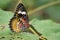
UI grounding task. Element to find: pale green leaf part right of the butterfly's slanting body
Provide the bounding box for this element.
[30,19,60,40]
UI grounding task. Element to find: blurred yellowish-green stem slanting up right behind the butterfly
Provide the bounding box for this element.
[28,1,60,15]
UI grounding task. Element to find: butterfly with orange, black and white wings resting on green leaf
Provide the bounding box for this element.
[9,3,47,40]
